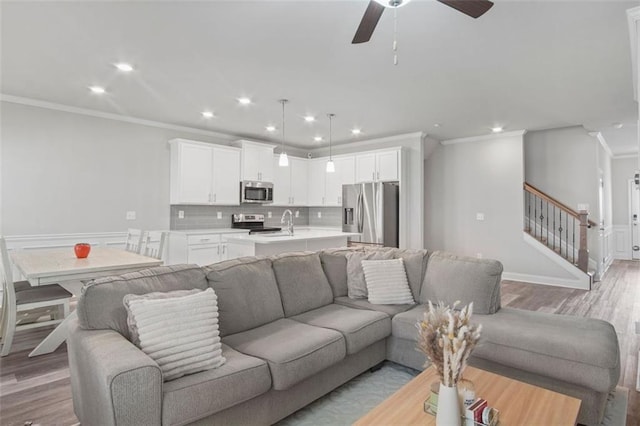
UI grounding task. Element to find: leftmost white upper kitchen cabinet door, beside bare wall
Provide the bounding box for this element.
[171,142,213,204]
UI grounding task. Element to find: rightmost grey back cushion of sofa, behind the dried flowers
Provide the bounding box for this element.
[420,251,502,314]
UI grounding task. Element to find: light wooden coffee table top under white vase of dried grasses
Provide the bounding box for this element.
[355,367,581,426]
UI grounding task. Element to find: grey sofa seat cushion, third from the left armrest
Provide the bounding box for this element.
[291,304,391,355]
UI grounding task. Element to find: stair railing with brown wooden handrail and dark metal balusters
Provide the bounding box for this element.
[523,182,596,288]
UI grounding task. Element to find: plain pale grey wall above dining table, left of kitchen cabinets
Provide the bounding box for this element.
[0,102,232,235]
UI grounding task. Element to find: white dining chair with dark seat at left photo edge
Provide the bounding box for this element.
[0,237,72,356]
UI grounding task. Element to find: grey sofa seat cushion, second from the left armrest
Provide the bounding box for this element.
[222,318,346,390]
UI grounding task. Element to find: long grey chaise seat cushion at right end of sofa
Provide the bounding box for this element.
[471,308,620,392]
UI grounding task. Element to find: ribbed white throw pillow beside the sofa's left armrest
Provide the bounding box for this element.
[123,288,226,381]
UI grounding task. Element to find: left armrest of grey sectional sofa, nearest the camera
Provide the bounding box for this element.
[67,319,162,425]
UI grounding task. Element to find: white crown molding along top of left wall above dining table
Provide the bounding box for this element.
[0,93,241,141]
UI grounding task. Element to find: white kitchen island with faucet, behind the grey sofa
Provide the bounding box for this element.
[227,229,360,257]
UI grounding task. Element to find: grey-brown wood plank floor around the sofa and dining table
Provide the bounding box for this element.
[0,261,640,426]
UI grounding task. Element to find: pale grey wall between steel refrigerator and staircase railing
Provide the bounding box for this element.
[424,132,572,282]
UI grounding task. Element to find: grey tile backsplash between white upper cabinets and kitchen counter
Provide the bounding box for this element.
[170,204,341,231]
